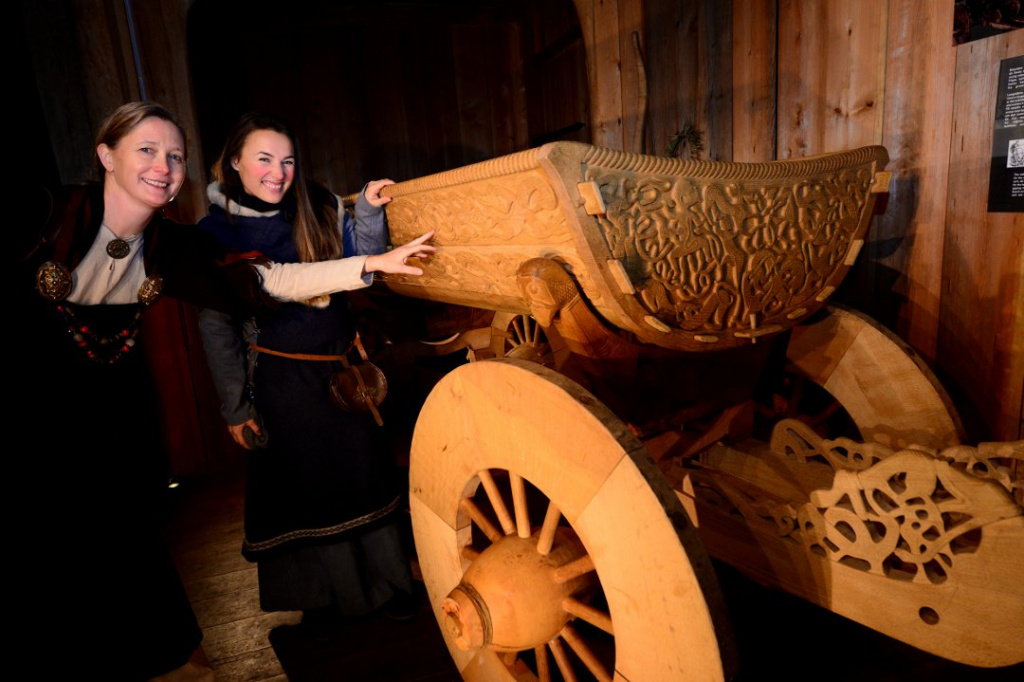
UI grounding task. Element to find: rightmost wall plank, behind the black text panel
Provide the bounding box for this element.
[937,30,1024,440]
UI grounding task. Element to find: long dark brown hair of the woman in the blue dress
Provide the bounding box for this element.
[211,112,342,262]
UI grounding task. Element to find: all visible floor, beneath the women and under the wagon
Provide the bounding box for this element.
[167,458,1024,682]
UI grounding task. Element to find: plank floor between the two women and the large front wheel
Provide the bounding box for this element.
[166,458,461,682]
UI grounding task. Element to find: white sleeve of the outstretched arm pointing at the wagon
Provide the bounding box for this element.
[253,256,374,301]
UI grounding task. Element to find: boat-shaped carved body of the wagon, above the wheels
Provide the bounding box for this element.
[383,142,888,350]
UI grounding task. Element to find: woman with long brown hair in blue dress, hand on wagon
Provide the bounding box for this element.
[200,113,430,636]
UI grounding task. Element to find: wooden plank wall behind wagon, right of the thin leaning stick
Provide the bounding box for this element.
[644,0,1024,440]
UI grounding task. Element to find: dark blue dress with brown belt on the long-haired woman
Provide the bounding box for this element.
[199,185,413,615]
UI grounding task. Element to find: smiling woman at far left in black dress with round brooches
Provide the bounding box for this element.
[14,102,218,682]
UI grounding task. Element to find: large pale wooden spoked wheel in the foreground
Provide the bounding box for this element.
[410,358,733,682]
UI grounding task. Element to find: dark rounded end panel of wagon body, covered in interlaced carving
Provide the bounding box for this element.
[587,166,873,333]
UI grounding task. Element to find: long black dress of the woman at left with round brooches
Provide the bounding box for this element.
[16,187,243,682]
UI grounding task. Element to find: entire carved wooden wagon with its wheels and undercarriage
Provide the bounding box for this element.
[350,142,1024,682]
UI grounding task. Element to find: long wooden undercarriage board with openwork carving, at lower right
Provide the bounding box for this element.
[679,420,1024,667]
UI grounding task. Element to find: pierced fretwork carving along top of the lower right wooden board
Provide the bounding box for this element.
[701,420,1024,584]
